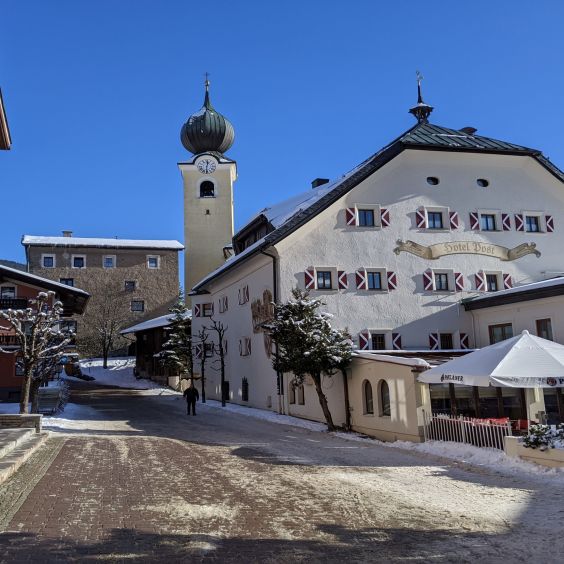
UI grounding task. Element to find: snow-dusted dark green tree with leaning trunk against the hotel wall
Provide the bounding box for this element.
[264,288,353,431]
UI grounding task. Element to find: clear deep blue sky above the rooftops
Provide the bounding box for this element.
[0,0,564,276]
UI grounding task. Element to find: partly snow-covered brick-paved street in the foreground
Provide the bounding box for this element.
[0,387,564,563]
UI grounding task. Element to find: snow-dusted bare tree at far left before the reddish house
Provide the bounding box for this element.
[0,292,70,413]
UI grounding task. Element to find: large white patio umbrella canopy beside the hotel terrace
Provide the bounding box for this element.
[417,331,564,388]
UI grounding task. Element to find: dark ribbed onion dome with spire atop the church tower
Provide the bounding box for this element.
[180,78,235,155]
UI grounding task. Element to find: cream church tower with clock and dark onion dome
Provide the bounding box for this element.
[178,78,237,299]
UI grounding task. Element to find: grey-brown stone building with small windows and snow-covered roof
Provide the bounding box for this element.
[22,231,183,352]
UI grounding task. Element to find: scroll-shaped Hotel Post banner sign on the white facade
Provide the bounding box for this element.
[394,239,541,261]
